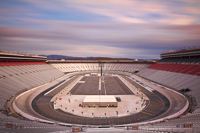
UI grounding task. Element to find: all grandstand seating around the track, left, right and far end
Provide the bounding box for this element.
[0,62,200,132]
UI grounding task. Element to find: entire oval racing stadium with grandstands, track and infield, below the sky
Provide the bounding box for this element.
[0,49,200,133]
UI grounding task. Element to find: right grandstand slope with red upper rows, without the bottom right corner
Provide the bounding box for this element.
[138,63,200,106]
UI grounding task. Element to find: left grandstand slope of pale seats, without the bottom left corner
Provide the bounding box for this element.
[0,63,63,109]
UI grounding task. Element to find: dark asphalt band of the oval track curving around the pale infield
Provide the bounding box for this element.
[32,74,170,125]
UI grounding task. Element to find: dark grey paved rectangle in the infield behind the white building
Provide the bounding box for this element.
[71,75,133,95]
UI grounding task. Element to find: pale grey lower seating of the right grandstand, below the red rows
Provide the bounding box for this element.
[138,64,200,107]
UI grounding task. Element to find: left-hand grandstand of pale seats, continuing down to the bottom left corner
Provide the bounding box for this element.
[0,62,64,132]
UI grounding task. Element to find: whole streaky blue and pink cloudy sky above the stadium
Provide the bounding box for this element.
[0,0,200,59]
